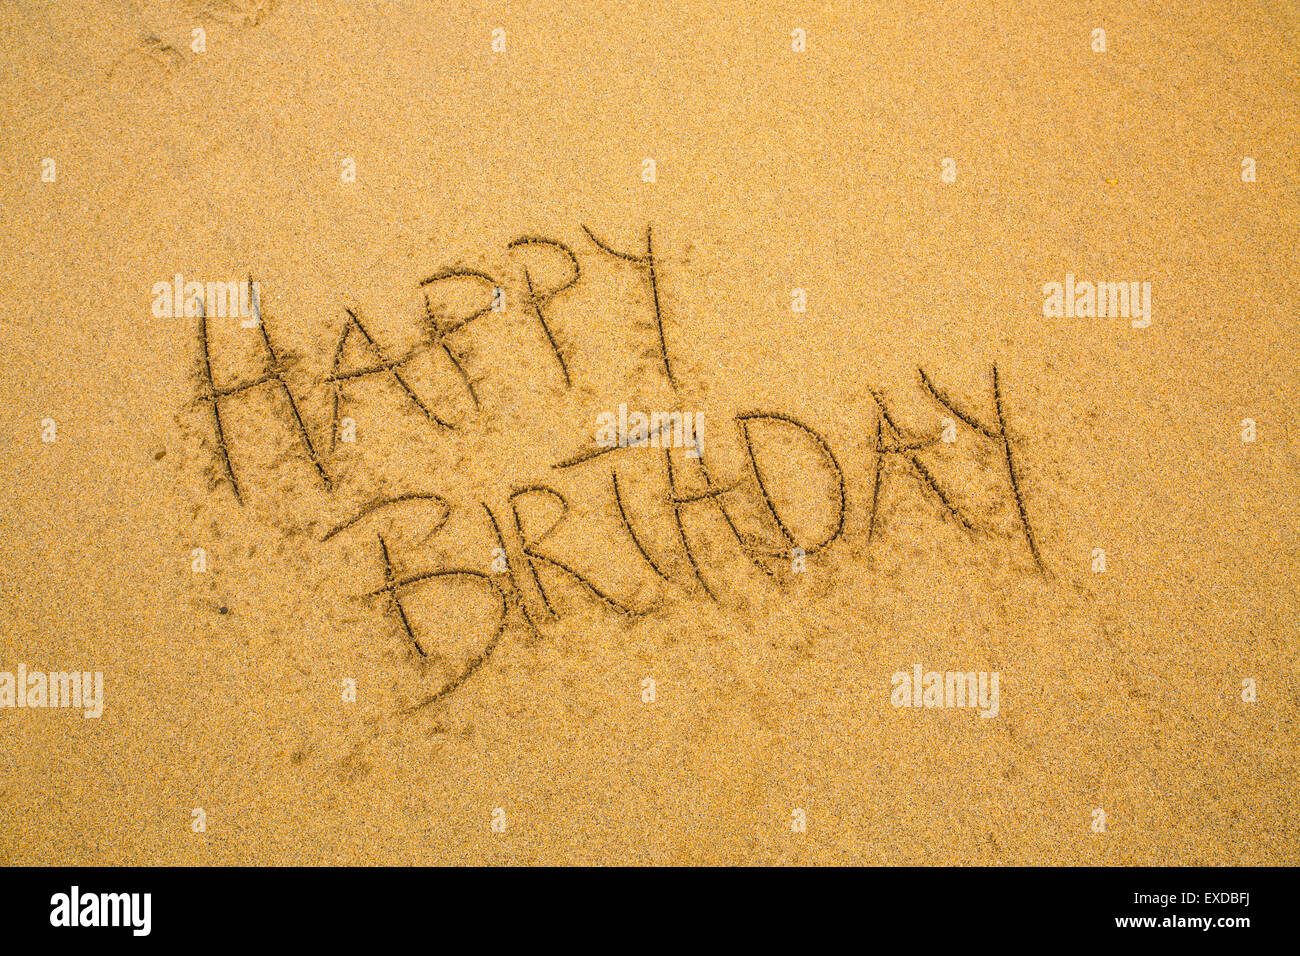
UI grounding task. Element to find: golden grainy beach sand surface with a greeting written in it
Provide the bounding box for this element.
[0,0,1300,865]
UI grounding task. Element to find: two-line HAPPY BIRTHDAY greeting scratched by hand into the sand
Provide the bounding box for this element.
[195,225,1060,717]
